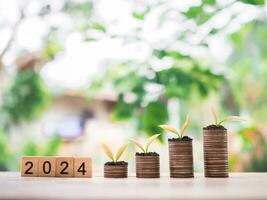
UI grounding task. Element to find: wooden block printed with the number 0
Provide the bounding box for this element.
[38,156,56,177]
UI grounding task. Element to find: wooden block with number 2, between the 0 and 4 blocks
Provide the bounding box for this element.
[56,157,74,177]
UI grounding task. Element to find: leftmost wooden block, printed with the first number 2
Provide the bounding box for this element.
[20,156,39,177]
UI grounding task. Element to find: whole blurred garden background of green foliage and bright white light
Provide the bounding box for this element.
[0,0,267,171]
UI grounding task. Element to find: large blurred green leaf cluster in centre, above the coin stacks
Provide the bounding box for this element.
[91,57,224,139]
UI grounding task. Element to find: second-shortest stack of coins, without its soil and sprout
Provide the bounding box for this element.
[135,155,160,178]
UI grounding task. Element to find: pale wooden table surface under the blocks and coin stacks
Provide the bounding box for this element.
[0,172,267,200]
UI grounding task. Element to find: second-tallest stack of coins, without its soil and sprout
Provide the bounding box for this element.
[169,140,194,178]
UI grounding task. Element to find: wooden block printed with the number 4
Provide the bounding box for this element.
[74,157,92,178]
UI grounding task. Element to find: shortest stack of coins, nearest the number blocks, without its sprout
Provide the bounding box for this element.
[104,163,128,178]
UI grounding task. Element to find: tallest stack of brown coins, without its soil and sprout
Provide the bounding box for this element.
[204,129,229,177]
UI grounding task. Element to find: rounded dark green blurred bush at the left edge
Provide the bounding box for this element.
[2,69,49,122]
